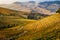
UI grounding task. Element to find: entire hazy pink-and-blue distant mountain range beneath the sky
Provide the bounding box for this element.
[0,1,60,15]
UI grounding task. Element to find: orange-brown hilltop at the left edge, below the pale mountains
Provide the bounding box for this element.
[0,7,24,14]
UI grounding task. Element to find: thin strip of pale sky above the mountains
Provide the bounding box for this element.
[0,0,59,4]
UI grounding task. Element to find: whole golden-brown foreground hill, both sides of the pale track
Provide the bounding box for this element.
[0,13,60,40]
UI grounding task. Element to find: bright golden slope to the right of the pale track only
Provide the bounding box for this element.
[18,14,60,40]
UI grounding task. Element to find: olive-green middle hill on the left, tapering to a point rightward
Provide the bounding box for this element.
[0,16,34,29]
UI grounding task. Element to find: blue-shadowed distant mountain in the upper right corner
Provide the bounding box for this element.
[39,1,60,12]
